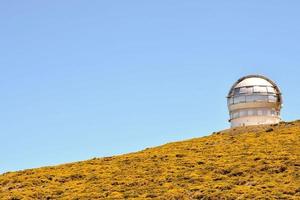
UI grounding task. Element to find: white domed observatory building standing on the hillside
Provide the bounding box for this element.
[227,75,282,127]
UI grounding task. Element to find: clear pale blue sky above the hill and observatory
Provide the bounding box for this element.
[0,0,300,172]
